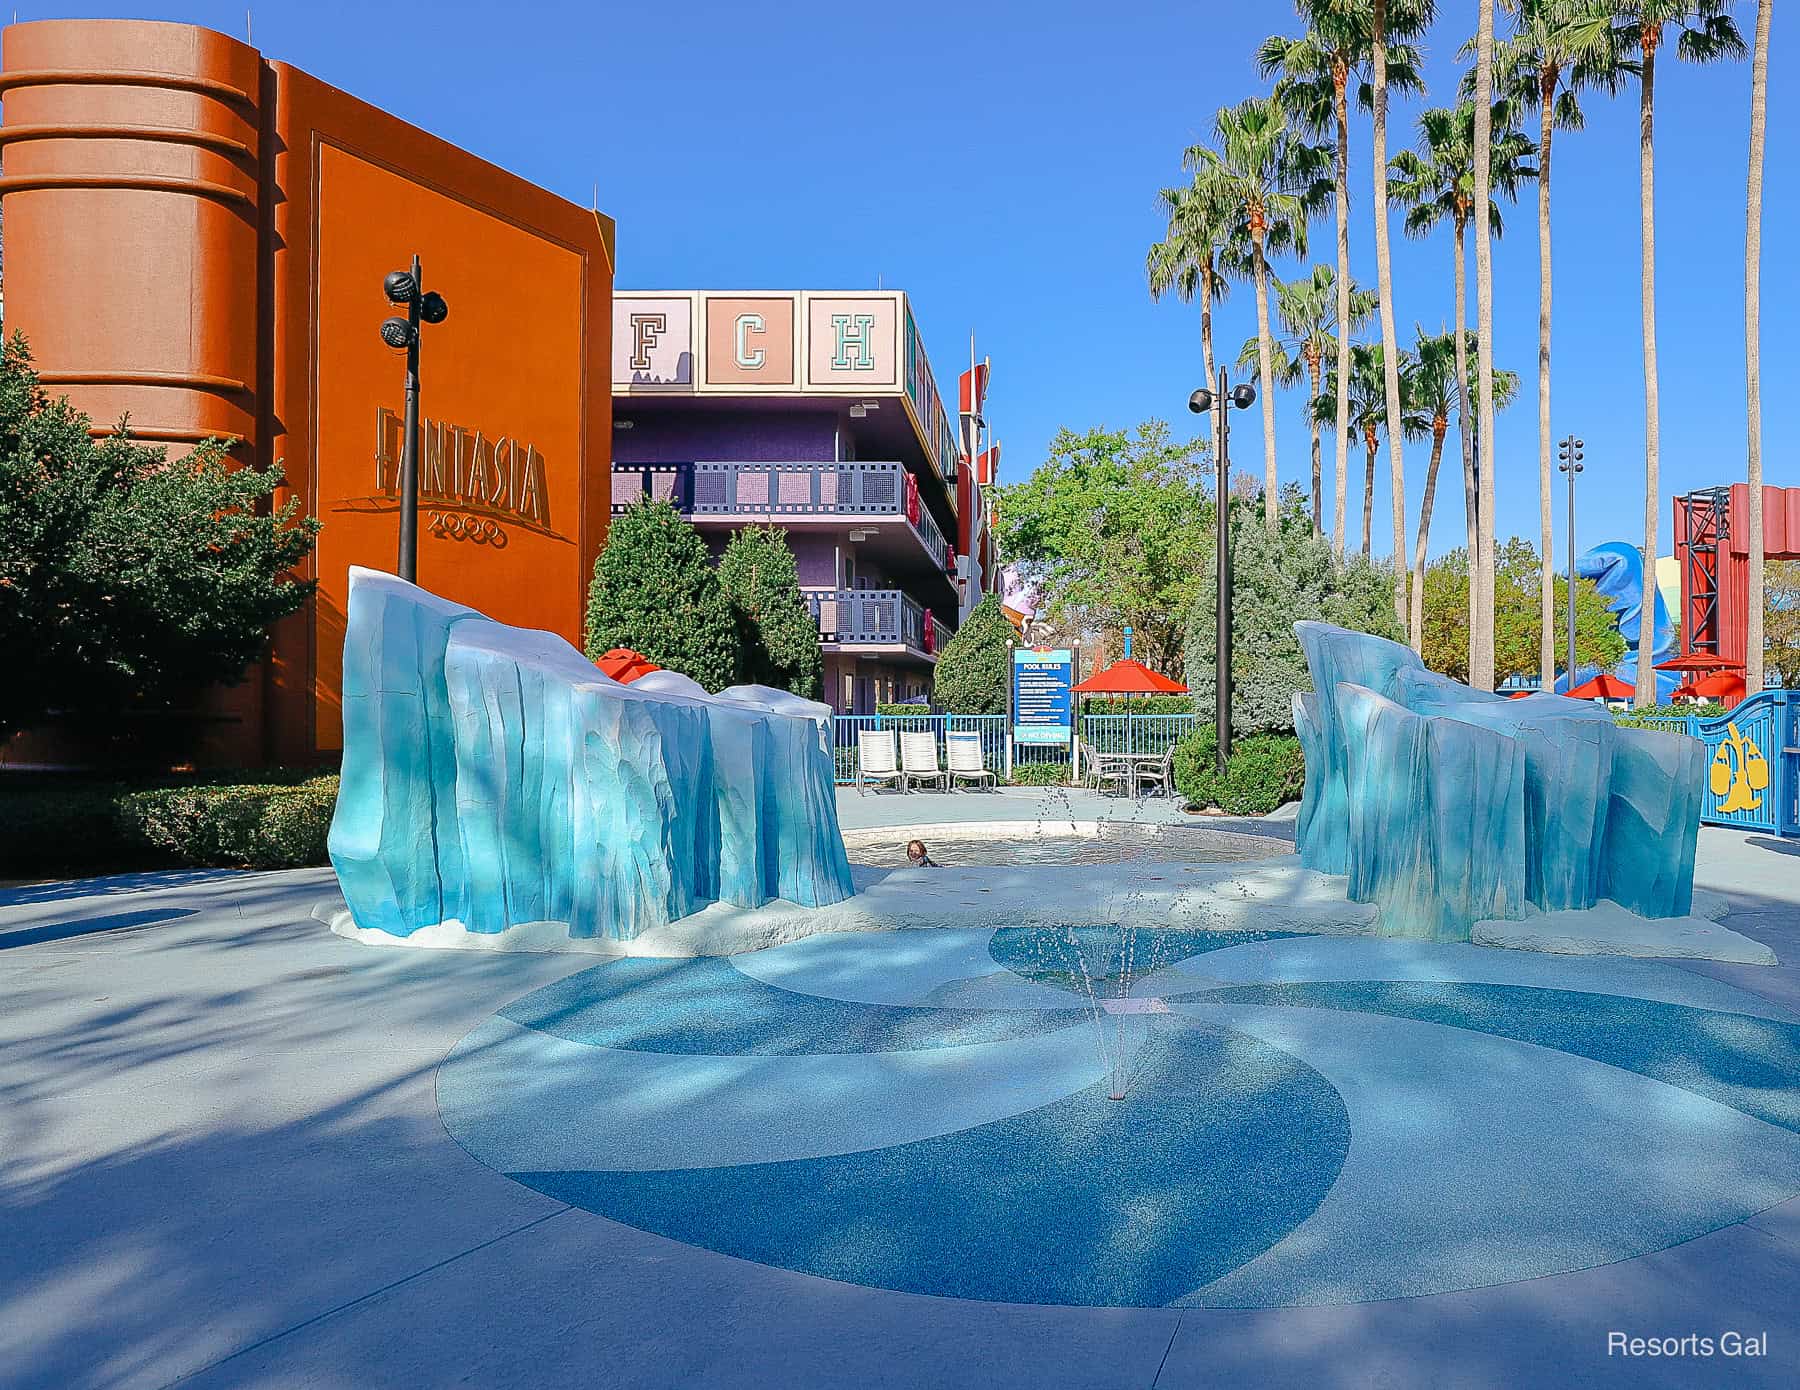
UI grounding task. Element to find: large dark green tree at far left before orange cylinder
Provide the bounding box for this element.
[0,333,319,740]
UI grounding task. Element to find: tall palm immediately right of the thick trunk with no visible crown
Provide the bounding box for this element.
[1490,0,1606,690]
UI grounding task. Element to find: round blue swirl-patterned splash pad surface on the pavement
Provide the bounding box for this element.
[437,927,1800,1307]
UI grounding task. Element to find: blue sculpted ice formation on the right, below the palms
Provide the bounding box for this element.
[1294,623,1705,942]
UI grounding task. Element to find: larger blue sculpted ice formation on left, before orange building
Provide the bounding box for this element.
[329,569,853,949]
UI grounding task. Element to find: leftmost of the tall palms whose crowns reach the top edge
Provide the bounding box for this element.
[1256,0,1422,560]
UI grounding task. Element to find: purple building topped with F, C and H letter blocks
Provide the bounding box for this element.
[612,292,981,713]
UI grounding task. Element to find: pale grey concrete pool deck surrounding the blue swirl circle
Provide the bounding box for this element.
[0,790,1800,1390]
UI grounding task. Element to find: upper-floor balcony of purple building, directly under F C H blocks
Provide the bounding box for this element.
[612,461,956,578]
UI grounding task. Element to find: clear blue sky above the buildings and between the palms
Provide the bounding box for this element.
[18,0,1800,555]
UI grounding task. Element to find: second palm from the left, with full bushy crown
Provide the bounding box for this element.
[1186,97,1330,531]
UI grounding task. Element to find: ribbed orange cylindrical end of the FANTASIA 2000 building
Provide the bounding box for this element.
[0,20,263,452]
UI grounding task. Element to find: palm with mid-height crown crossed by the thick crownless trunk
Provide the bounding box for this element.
[1391,101,1534,655]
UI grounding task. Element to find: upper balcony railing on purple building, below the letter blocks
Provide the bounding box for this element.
[612,461,956,573]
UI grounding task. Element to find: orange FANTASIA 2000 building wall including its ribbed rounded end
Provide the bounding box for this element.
[0,20,612,762]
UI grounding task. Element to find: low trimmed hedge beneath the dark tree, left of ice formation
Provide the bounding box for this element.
[0,772,338,877]
